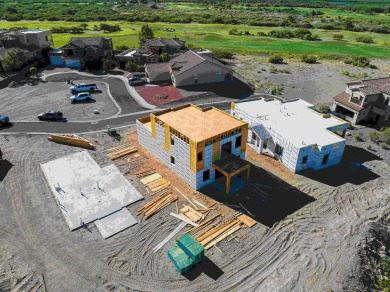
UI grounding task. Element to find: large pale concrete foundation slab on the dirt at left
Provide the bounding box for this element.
[41,151,143,230]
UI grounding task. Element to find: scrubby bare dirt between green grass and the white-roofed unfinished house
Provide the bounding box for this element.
[229,55,390,105]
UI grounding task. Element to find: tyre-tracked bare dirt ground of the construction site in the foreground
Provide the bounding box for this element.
[0,128,390,291]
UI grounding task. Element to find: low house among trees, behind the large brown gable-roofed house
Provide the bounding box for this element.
[115,38,186,67]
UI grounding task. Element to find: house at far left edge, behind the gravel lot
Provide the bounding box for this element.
[0,30,54,71]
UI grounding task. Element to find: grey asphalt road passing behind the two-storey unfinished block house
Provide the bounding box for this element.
[0,102,230,135]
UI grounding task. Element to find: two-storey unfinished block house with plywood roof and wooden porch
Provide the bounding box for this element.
[137,104,249,192]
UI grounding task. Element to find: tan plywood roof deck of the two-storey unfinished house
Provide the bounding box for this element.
[157,106,246,142]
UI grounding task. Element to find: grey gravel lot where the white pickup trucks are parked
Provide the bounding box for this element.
[0,82,119,121]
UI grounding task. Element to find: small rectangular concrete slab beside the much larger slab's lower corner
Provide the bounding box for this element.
[95,208,137,239]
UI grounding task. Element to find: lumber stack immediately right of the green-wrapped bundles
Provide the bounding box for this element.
[195,219,241,250]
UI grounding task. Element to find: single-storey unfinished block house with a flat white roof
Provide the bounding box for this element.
[231,98,348,172]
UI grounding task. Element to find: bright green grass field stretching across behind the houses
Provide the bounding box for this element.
[0,21,390,57]
